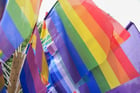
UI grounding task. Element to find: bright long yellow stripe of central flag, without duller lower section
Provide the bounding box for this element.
[59,0,106,64]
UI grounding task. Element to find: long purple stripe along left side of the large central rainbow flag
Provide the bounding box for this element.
[46,18,81,83]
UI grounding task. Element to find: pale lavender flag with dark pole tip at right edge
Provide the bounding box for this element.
[121,23,140,73]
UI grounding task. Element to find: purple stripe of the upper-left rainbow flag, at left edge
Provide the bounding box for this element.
[0,26,15,61]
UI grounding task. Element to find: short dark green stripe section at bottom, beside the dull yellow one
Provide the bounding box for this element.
[91,66,111,93]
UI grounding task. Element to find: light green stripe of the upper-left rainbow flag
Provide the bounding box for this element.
[7,0,32,39]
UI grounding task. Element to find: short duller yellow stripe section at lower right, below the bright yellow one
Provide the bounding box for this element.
[100,60,120,89]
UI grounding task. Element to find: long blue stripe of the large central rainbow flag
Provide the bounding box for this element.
[49,9,88,76]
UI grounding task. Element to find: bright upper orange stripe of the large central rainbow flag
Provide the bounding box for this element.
[73,5,110,54]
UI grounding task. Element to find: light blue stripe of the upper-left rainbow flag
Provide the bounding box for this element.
[1,11,24,49]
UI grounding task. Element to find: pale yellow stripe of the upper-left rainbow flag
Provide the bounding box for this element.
[16,0,37,28]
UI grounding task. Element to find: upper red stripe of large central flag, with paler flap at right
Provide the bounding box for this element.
[82,0,130,41]
